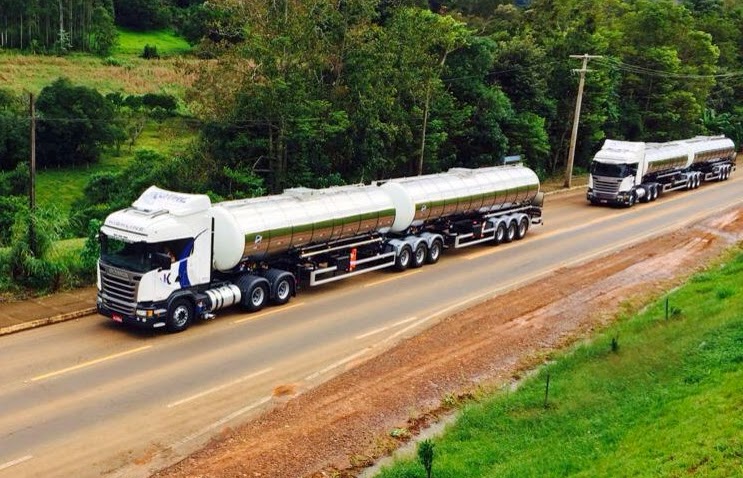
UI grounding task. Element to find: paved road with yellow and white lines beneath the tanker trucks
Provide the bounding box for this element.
[0,172,743,478]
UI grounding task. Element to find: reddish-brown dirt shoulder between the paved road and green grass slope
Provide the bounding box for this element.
[155,208,743,478]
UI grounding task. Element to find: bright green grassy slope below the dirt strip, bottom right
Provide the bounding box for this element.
[379,248,743,478]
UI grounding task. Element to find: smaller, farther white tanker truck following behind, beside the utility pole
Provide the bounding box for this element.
[586,136,735,207]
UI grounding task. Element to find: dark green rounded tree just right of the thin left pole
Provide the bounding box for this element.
[36,78,117,166]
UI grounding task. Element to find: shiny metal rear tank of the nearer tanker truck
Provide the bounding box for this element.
[381,165,539,232]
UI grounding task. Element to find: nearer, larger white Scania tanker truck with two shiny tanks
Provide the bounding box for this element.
[97,165,543,332]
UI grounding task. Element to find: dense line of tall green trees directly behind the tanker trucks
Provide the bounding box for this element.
[182,0,743,195]
